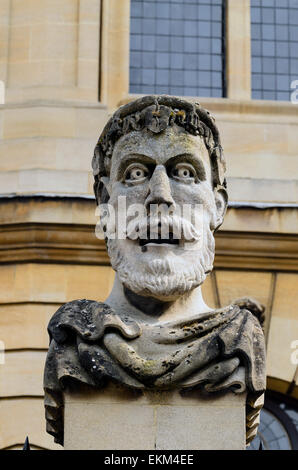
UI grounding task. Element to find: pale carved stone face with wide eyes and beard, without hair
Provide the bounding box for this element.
[102,125,226,300]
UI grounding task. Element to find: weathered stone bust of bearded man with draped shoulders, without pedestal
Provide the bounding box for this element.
[44,95,266,444]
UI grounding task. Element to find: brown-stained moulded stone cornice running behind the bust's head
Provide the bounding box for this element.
[0,222,298,271]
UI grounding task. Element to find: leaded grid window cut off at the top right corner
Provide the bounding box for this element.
[251,0,298,101]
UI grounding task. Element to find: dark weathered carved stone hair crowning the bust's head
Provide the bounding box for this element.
[92,95,226,202]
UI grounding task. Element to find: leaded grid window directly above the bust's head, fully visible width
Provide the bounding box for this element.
[130,0,225,97]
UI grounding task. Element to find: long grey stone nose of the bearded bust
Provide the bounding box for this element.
[145,165,175,210]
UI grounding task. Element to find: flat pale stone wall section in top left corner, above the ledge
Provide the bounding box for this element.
[0,0,101,103]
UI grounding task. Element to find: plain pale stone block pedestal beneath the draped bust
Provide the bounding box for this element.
[64,385,246,450]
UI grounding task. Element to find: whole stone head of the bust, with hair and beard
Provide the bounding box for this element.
[92,95,227,300]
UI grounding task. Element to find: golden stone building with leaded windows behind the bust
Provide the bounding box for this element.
[0,0,298,449]
